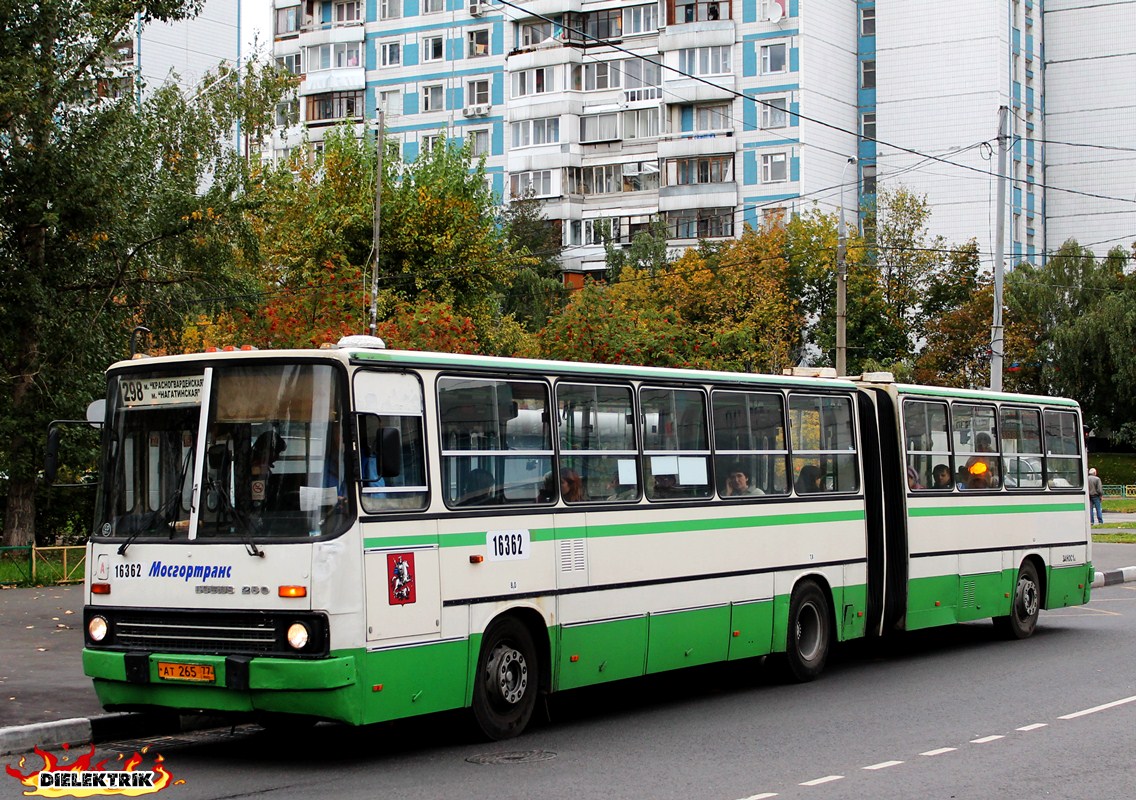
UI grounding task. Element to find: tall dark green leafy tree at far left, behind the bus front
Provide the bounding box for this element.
[0,0,284,544]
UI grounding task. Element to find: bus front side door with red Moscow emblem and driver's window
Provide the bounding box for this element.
[354,370,442,642]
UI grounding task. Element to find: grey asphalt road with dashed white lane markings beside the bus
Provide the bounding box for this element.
[0,563,1136,800]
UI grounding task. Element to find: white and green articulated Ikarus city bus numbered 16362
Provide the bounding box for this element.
[83,338,1092,739]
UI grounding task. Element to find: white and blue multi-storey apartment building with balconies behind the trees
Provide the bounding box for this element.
[274,0,1136,272]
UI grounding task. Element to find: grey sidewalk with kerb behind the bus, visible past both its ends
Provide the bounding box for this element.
[0,543,1136,756]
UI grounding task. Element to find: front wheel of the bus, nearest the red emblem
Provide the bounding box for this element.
[473,617,541,741]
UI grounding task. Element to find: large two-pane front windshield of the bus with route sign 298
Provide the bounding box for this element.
[95,364,353,541]
